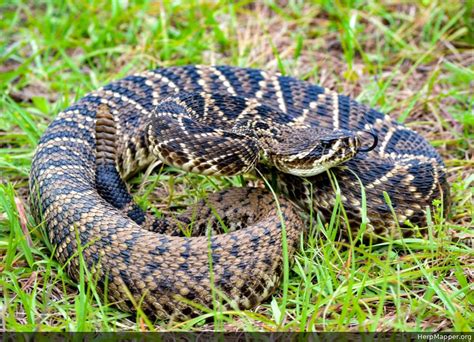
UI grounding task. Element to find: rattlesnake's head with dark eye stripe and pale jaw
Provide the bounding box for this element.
[263,127,368,177]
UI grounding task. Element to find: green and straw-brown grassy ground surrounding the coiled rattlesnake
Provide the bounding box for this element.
[0,0,474,331]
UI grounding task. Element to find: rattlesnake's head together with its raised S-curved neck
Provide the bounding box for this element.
[124,93,360,177]
